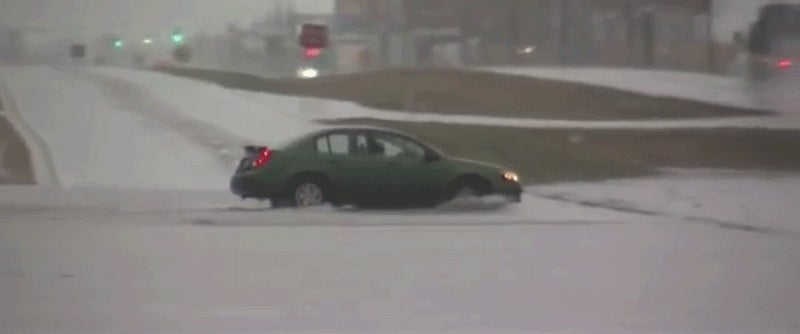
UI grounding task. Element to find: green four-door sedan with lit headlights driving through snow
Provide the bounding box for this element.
[230,127,522,208]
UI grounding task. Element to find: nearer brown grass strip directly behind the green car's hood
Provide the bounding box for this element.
[318,119,800,184]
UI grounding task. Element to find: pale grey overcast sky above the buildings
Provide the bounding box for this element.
[0,0,797,39]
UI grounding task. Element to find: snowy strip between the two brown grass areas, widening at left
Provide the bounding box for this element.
[83,68,800,134]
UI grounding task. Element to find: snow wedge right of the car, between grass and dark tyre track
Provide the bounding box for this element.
[529,170,800,237]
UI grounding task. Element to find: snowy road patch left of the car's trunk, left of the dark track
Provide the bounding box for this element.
[0,67,241,189]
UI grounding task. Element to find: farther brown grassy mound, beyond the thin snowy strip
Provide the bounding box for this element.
[154,67,771,120]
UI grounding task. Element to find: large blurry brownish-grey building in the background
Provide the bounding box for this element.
[334,0,715,70]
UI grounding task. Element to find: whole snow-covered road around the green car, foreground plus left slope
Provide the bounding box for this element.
[0,67,800,334]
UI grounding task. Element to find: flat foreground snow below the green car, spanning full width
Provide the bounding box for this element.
[0,181,800,334]
